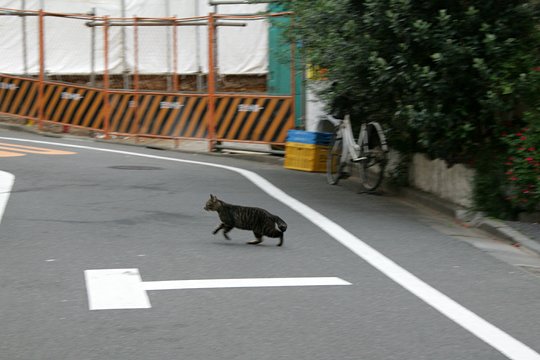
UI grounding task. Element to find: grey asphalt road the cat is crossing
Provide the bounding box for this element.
[0,130,540,360]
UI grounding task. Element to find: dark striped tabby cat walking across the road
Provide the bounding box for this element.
[204,195,287,246]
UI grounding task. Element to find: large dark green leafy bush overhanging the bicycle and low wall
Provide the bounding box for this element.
[280,0,540,217]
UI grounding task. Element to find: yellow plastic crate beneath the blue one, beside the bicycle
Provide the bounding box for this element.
[284,142,328,172]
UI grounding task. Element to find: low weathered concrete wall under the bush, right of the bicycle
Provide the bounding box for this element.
[409,154,474,207]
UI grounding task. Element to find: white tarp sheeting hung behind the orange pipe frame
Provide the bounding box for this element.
[0,0,268,74]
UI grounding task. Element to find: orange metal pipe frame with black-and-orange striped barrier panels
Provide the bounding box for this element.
[0,7,295,151]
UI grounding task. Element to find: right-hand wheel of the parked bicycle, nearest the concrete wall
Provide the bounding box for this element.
[358,124,387,192]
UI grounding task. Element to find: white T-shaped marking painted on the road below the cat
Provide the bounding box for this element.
[84,269,351,310]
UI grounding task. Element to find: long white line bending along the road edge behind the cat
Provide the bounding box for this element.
[4,137,540,360]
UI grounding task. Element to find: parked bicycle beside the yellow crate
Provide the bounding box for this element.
[326,115,388,192]
